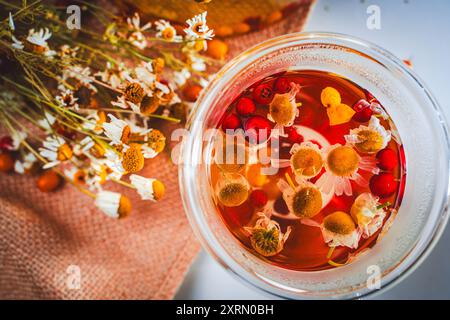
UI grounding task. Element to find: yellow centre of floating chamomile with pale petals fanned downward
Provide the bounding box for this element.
[327,146,359,177]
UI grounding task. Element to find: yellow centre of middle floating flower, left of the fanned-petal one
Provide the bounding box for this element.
[291,148,323,177]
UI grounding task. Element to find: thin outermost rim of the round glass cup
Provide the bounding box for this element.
[179,32,450,299]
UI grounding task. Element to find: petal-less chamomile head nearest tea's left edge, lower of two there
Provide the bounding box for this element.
[216,173,250,207]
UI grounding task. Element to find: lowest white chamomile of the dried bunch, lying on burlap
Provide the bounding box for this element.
[95,191,131,219]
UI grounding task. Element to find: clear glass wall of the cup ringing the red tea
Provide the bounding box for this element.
[179,33,449,299]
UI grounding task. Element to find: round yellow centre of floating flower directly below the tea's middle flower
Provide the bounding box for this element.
[292,187,322,218]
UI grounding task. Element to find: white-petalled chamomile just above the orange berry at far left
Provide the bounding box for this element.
[39,136,73,169]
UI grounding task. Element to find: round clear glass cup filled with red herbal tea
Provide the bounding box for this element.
[179,33,449,299]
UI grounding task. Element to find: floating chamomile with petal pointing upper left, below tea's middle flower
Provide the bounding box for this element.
[277,179,323,218]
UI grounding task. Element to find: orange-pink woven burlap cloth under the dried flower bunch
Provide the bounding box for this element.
[0,0,313,299]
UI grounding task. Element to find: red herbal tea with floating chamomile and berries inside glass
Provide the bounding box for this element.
[210,71,406,271]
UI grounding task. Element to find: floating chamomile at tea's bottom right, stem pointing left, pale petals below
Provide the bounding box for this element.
[301,211,361,249]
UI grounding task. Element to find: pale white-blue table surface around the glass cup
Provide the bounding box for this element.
[175,0,450,299]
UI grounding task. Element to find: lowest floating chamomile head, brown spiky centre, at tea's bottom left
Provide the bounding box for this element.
[245,212,291,257]
